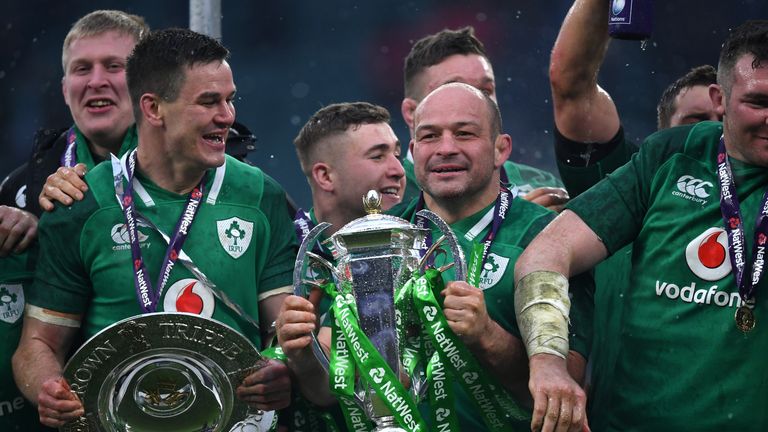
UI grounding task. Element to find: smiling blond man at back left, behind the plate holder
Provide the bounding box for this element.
[0,10,149,221]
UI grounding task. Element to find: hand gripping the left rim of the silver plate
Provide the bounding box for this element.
[37,377,85,427]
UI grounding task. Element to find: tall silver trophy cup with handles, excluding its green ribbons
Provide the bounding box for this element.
[293,191,466,431]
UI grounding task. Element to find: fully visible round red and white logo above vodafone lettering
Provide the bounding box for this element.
[685,228,731,281]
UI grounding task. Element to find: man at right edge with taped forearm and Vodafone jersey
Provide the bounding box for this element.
[515,20,768,431]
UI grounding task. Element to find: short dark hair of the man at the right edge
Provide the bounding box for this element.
[717,20,768,97]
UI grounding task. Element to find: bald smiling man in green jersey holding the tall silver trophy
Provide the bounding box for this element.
[277,83,591,431]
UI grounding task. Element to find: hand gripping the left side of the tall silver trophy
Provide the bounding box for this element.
[275,295,317,366]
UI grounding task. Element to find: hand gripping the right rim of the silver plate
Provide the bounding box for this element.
[236,360,291,411]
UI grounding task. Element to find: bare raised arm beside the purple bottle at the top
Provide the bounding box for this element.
[549,0,620,143]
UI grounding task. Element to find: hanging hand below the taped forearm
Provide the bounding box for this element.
[528,354,589,432]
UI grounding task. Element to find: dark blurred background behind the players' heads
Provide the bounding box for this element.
[0,0,768,208]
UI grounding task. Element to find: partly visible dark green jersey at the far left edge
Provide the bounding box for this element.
[0,246,46,432]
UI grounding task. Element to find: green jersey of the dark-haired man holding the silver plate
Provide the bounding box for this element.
[29,156,296,347]
